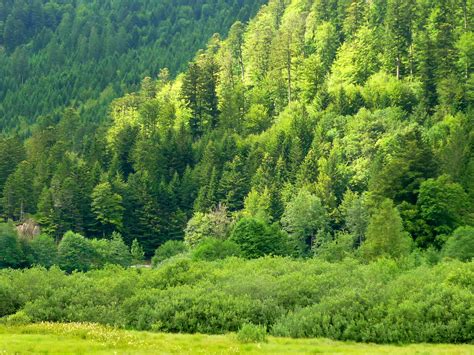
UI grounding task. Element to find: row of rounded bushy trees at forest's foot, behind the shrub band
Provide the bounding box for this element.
[0,220,474,273]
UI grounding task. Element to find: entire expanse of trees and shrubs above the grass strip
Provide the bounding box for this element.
[0,0,474,343]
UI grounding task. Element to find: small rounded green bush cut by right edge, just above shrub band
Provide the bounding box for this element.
[442,226,474,261]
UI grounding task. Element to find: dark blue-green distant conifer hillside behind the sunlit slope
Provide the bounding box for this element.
[0,0,264,135]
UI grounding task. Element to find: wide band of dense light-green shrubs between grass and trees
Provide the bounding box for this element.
[0,257,474,343]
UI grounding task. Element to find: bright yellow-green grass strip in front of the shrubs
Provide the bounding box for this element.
[0,323,474,354]
